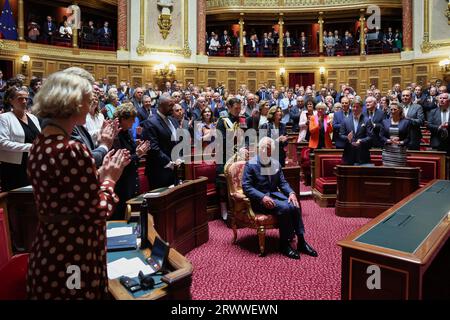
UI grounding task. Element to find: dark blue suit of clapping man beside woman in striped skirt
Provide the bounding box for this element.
[339,114,372,165]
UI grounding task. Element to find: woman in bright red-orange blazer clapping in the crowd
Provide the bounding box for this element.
[309,102,333,149]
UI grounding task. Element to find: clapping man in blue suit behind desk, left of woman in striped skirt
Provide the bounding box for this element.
[339,97,372,165]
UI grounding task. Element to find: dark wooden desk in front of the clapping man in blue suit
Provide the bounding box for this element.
[335,166,420,218]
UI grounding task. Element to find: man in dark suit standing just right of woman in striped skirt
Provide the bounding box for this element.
[402,90,425,150]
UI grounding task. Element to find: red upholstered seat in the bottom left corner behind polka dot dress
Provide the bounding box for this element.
[0,253,28,300]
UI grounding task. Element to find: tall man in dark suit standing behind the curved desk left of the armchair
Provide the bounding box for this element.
[141,93,181,190]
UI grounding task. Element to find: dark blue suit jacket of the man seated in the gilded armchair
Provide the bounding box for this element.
[242,157,294,212]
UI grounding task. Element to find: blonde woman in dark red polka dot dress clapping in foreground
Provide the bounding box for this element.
[27,72,130,299]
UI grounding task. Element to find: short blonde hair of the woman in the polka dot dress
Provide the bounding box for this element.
[33,71,92,118]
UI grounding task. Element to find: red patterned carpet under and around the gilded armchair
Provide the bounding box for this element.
[187,185,369,300]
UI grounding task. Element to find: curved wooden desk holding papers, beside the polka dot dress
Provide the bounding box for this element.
[107,215,193,300]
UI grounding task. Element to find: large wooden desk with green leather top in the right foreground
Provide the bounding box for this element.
[338,180,450,300]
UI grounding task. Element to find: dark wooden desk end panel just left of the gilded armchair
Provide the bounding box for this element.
[127,177,209,254]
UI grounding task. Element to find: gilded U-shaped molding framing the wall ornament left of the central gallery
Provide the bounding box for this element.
[136,0,192,58]
